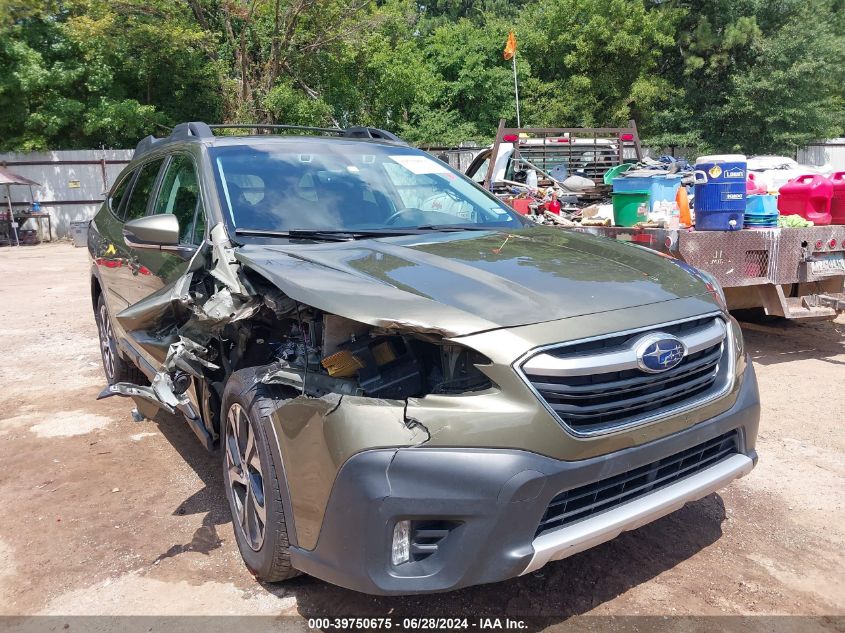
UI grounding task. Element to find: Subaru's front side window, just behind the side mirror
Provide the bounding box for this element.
[153,154,205,244]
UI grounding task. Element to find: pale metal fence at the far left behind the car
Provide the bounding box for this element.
[0,149,135,238]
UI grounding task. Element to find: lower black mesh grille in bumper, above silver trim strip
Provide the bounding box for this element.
[535,431,739,536]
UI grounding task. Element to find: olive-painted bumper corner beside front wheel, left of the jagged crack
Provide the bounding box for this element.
[271,393,428,549]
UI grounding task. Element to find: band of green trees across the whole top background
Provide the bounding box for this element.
[0,0,845,153]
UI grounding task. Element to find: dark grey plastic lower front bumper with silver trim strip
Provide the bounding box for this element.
[291,364,760,594]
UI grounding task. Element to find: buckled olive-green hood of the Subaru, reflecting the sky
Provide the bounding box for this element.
[236,226,715,336]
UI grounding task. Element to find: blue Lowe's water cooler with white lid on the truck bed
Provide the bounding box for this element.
[695,154,748,231]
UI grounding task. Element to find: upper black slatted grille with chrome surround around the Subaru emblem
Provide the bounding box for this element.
[522,317,729,434]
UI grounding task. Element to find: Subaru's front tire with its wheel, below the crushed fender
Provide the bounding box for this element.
[220,369,299,582]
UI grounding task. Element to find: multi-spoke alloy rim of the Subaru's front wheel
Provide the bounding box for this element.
[224,404,267,552]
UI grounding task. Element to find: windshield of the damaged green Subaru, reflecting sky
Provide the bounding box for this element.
[211,139,524,233]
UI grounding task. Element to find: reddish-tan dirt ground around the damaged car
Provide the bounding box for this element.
[0,244,845,622]
